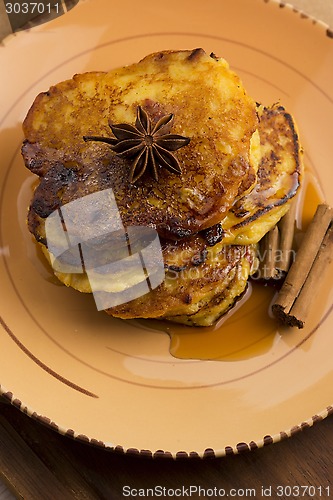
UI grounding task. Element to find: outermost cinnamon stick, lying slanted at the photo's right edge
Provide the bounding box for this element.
[272,204,333,328]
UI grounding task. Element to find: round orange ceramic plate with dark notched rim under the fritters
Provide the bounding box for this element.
[0,0,333,456]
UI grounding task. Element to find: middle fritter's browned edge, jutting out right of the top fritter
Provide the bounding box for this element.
[147,105,302,269]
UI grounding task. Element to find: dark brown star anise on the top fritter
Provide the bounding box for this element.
[83,106,190,183]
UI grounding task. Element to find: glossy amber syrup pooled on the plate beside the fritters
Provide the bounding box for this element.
[164,170,323,361]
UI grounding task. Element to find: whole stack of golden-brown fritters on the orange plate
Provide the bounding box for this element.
[22,49,301,326]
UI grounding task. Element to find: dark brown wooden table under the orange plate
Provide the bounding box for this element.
[0,0,333,500]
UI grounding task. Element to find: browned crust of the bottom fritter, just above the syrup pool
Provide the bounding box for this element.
[106,245,256,326]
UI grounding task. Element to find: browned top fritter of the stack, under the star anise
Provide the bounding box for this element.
[22,50,257,241]
